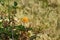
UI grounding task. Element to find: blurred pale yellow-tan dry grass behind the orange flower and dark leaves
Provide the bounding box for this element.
[0,0,60,40]
